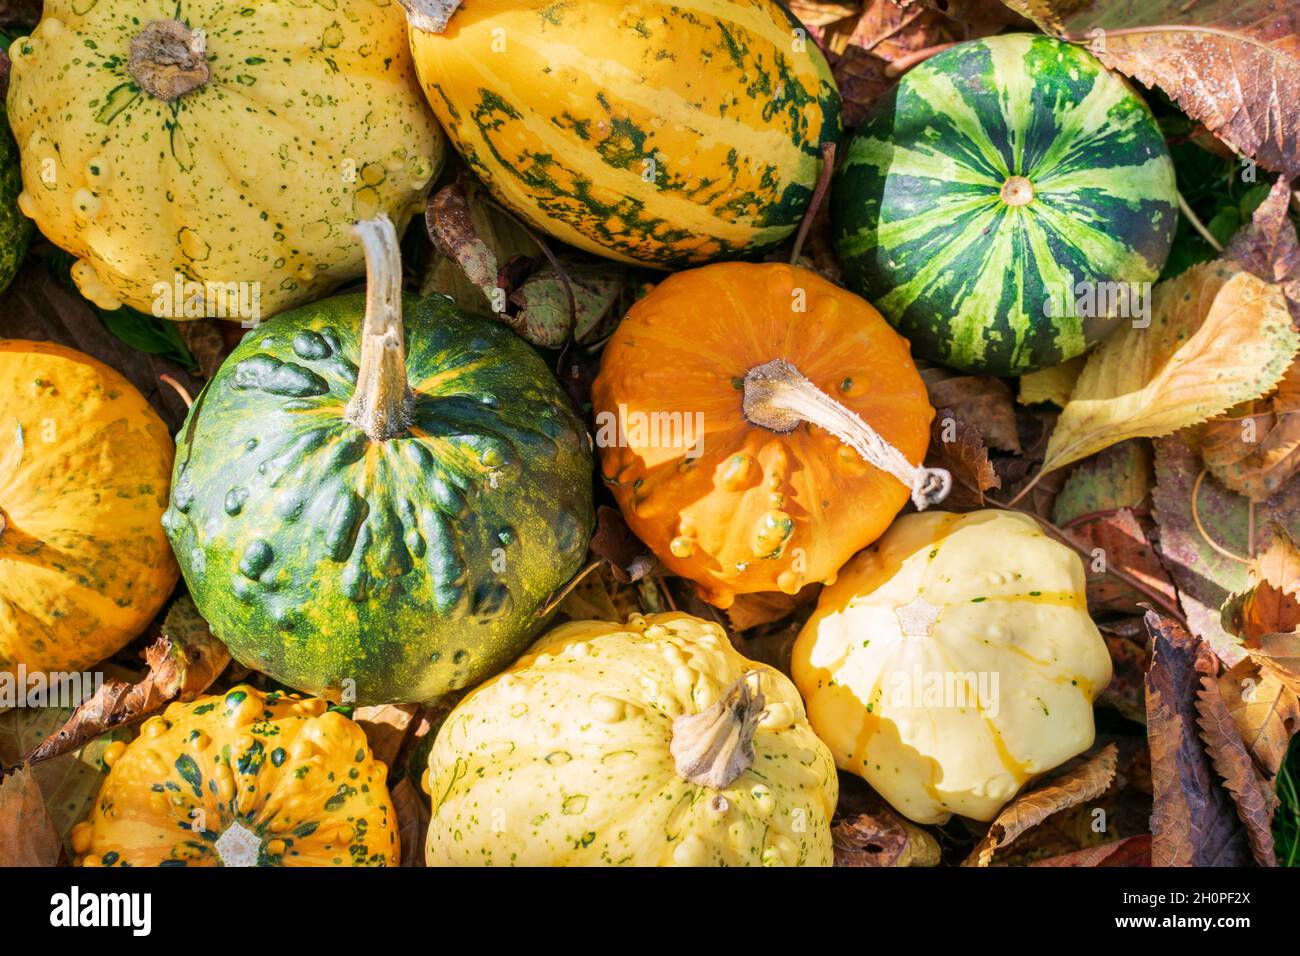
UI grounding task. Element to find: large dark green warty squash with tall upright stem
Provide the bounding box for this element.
[164,219,594,704]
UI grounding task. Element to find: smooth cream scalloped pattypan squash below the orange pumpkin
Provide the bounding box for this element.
[792,511,1110,823]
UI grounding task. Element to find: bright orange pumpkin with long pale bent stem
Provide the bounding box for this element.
[593,263,950,607]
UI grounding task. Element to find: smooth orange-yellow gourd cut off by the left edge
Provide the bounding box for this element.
[0,339,178,674]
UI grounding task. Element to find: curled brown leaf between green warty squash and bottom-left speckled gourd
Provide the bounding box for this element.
[27,596,230,762]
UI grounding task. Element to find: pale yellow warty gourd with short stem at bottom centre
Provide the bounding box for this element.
[425,614,839,866]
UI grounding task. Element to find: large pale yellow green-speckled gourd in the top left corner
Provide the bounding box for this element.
[8,0,446,319]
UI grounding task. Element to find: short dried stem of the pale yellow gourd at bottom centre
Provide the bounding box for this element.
[668,671,767,790]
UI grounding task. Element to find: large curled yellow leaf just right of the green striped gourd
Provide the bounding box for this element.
[1043,260,1300,473]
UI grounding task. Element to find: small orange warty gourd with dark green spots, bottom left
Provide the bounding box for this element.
[72,685,399,866]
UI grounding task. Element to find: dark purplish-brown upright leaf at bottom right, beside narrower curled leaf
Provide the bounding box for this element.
[1145,611,1253,866]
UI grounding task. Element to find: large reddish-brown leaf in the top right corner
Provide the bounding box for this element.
[1005,0,1300,178]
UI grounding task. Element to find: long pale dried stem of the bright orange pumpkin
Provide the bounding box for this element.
[744,359,953,511]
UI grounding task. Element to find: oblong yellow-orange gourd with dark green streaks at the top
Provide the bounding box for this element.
[402,0,840,268]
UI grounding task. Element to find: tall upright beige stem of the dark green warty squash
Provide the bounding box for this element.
[343,215,411,442]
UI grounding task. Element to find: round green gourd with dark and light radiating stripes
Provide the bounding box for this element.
[832,34,1177,375]
